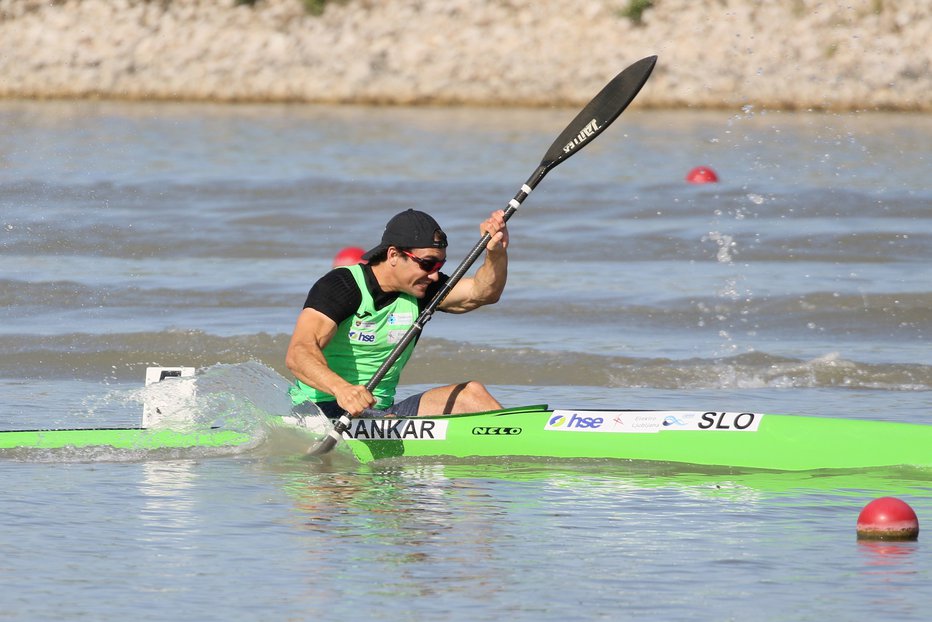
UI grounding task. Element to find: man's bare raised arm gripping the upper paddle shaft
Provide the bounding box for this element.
[440,210,508,313]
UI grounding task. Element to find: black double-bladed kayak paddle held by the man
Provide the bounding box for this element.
[307,56,657,456]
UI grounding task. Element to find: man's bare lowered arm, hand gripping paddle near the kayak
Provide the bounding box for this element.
[285,308,375,417]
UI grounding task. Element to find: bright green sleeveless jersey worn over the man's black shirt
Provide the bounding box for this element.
[289,265,420,409]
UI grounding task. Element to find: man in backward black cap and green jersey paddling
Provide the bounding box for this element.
[285,209,508,417]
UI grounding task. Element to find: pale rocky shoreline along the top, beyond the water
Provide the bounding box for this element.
[0,0,932,111]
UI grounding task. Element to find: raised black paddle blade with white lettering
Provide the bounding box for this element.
[540,56,657,171]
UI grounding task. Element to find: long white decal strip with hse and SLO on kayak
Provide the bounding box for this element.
[544,410,764,434]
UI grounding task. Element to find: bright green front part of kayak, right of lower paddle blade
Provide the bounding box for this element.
[344,406,932,471]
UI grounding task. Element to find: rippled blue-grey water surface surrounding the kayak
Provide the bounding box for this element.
[0,102,932,620]
